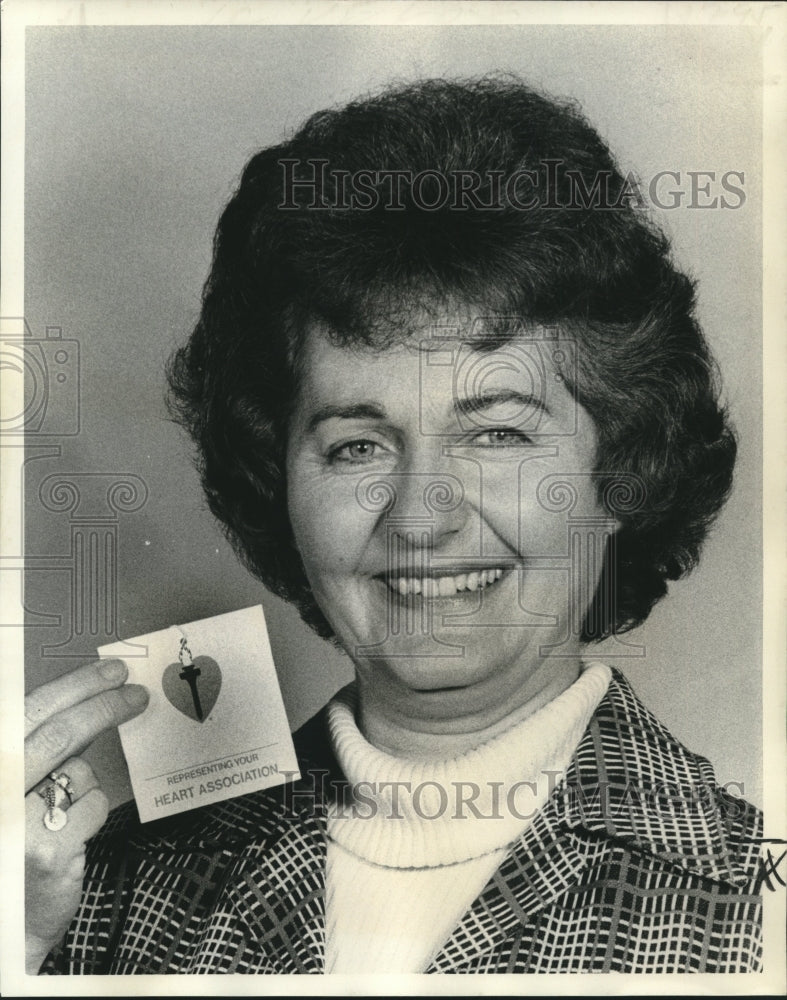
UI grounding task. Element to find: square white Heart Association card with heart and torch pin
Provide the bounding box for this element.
[98,605,300,823]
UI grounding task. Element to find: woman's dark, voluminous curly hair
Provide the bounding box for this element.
[168,76,736,642]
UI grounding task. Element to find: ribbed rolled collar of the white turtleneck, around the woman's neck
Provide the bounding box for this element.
[327,663,611,868]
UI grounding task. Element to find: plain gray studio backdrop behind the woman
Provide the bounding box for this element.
[25,26,762,803]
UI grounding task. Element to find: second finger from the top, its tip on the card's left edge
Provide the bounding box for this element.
[25,684,148,789]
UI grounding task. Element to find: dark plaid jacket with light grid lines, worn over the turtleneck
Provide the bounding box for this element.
[42,672,761,974]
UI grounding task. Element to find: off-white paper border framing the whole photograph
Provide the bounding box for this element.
[0,0,787,996]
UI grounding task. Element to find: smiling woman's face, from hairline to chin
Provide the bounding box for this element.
[287,325,613,727]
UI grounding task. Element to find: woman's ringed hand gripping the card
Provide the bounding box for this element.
[25,660,148,974]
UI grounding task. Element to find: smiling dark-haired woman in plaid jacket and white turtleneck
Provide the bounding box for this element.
[27,79,760,973]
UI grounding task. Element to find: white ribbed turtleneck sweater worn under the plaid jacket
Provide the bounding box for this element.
[325,661,611,973]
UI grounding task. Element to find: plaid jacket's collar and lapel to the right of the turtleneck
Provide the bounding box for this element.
[427,670,758,972]
